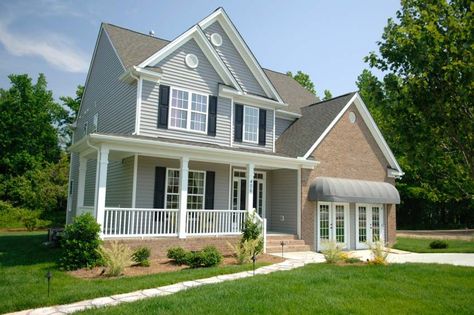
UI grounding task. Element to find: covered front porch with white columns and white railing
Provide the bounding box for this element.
[68,133,314,247]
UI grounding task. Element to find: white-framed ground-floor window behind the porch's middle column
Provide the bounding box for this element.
[166,169,206,209]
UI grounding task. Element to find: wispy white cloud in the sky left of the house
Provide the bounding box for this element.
[0,23,89,73]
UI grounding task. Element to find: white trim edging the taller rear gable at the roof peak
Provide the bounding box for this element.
[198,8,284,103]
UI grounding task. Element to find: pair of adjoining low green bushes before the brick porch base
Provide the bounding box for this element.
[167,246,222,268]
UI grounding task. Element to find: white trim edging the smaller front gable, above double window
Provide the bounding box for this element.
[138,25,242,91]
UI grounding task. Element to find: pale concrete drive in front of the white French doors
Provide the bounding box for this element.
[284,249,474,267]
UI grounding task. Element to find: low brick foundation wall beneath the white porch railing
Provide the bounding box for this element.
[105,236,240,258]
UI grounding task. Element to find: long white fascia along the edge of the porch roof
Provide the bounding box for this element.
[77,134,318,169]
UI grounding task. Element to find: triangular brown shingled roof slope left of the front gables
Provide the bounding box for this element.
[102,23,170,68]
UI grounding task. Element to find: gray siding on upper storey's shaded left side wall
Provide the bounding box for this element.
[74,31,137,141]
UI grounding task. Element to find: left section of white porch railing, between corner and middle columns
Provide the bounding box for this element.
[102,208,178,237]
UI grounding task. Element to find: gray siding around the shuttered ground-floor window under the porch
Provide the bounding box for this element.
[137,157,229,210]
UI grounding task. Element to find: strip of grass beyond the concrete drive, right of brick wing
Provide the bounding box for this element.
[393,237,474,253]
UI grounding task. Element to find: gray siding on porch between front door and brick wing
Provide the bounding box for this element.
[269,169,297,234]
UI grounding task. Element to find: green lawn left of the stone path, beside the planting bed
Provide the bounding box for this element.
[0,232,262,314]
